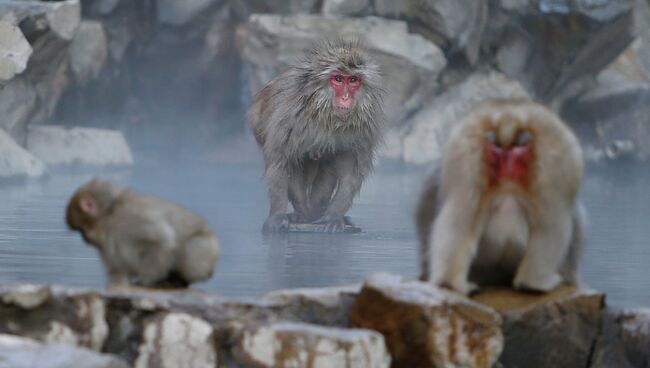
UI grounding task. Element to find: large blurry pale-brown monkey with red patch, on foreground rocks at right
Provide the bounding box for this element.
[417,100,583,294]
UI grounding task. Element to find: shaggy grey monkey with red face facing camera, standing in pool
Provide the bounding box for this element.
[248,41,383,232]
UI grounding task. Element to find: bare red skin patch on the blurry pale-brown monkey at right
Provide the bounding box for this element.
[485,132,533,187]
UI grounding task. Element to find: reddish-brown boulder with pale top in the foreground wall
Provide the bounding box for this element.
[350,274,503,368]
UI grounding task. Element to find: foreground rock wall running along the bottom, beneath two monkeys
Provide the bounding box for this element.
[0,273,650,368]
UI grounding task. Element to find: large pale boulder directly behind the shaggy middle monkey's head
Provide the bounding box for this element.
[238,14,446,125]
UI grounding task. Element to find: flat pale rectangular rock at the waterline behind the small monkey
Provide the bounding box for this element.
[27,125,133,166]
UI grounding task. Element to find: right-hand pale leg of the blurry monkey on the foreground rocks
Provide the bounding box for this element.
[513,210,573,291]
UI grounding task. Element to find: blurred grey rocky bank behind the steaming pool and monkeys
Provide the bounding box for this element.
[0,0,650,176]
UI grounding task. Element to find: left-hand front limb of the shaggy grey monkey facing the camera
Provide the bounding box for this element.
[262,164,290,233]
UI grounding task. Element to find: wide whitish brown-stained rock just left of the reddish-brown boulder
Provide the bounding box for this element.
[234,322,391,368]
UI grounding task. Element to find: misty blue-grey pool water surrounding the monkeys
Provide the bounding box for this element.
[0,164,650,306]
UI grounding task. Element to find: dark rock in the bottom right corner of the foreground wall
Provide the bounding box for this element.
[590,308,650,368]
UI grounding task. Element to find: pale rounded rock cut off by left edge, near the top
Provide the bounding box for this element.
[0,21,32,85]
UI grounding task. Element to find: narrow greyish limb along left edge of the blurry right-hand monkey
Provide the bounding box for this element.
[415,167,440,281]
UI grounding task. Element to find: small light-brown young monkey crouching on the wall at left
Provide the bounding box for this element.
[66,179,219,287]
